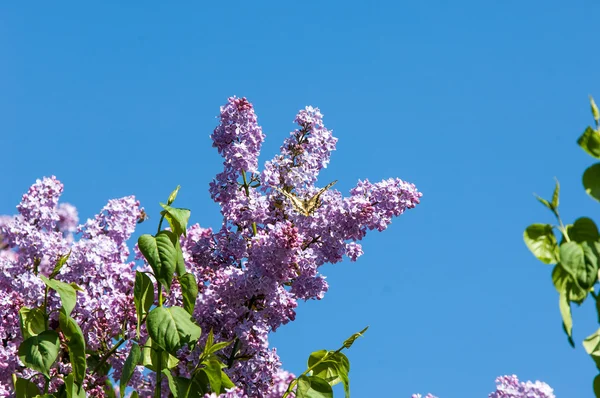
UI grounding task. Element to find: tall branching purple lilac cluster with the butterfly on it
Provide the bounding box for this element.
[159,97,421,397]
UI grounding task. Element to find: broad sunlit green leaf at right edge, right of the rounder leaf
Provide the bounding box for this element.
[560,241,600,289]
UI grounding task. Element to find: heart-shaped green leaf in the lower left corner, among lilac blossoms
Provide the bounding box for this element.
[19,330,60,378]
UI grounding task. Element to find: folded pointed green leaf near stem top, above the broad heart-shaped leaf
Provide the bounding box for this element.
[138,231,177,293]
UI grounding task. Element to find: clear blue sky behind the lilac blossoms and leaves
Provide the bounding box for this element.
[0,0,600,398]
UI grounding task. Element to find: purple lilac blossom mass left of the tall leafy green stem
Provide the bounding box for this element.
[0,177,140,396]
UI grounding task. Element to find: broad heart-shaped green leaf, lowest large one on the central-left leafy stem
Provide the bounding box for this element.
[146,307,201,354]
